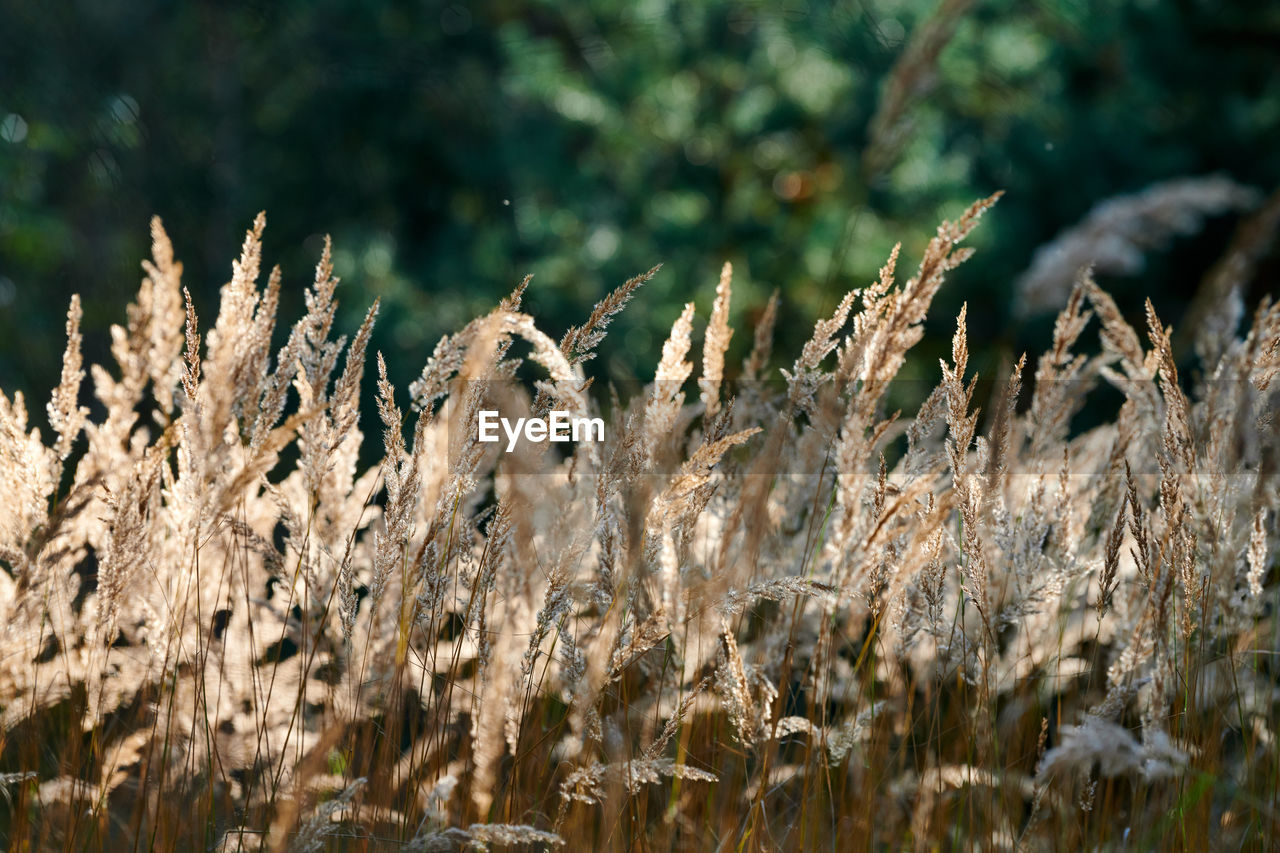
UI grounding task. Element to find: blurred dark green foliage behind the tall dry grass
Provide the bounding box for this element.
[0,0,1280,409]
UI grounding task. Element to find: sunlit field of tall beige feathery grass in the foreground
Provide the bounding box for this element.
[0,197,1280,850]
